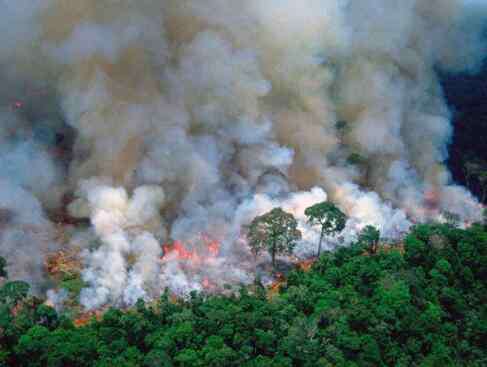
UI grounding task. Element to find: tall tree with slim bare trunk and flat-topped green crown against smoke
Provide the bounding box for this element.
[304,202,347,256]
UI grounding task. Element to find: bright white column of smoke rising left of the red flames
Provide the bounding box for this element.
[70,180,164,308]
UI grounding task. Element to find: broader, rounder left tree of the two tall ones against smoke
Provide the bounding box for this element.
[247,208,301,267]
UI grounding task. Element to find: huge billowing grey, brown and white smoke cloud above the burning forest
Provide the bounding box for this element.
[0,0,486,308]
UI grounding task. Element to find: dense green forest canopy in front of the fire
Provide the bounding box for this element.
[0,225,487,367]
